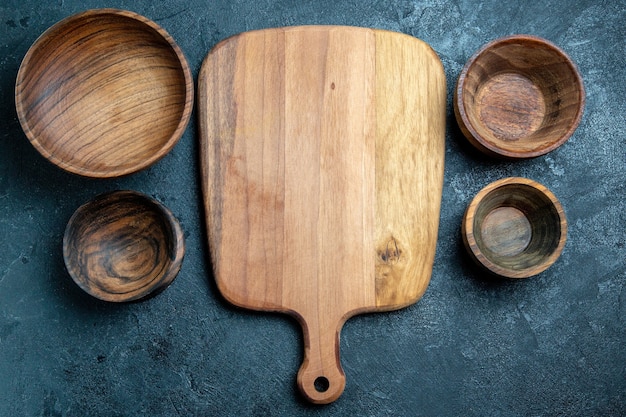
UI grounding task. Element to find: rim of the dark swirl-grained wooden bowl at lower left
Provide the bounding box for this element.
[63,190,185,302]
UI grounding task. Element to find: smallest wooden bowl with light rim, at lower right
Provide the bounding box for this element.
[461,177,567,278]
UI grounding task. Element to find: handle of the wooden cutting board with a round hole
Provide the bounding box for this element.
[298,319,346,404]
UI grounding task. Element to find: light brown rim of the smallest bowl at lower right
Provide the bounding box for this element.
[461,177,567,278]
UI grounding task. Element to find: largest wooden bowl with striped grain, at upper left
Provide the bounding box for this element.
[15,9,193,178]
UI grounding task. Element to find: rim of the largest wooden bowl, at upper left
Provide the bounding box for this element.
[15,8,194,178]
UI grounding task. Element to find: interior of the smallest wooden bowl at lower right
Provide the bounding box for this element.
[473,184,563,272]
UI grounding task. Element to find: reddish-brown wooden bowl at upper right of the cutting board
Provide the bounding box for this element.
[454,35,585,159]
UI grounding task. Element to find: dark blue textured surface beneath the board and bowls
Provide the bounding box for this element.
[0,0,626,416]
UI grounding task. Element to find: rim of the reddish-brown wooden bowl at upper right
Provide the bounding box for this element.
[452,34,586,159]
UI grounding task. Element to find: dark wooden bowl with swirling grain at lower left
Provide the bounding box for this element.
[63,191,185,302]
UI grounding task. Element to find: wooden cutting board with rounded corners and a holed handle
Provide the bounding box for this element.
[198,26,446,403]
